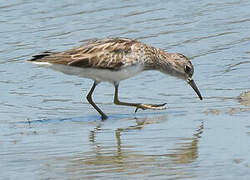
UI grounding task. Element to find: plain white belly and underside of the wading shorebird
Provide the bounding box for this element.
[31,62,143,83]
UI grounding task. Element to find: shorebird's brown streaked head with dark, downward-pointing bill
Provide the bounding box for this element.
[160,53,202,100]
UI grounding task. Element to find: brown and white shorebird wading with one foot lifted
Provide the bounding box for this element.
[28,38,202,119]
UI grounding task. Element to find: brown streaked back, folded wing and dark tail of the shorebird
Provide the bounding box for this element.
[29,38,146,71]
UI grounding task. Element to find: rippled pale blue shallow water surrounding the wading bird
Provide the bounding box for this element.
[0,0,250,180]
